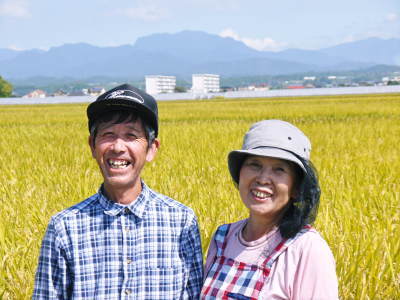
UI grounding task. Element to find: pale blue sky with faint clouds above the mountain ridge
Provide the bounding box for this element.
[0,0,400,51]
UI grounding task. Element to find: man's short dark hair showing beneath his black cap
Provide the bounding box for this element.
[90,110,155,147]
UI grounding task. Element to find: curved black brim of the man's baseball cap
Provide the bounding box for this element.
[87,99,158,137]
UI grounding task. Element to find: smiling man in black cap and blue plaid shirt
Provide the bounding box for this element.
[33,84,203,300]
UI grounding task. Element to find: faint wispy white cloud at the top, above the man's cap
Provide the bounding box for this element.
[114,4,169,22]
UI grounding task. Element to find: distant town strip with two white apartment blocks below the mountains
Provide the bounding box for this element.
[15,72,400,98]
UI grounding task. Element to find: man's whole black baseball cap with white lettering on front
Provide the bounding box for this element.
[86,84,158,137]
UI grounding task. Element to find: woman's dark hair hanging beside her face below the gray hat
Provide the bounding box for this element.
[279,157,321,238]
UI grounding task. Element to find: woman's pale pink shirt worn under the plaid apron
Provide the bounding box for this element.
[205,220,338,300]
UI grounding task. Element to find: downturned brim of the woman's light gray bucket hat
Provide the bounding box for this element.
[228,147,307,184]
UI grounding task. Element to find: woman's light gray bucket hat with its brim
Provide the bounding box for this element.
[228,120,311,184]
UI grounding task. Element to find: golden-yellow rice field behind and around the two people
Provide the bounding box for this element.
[0,94,400,299]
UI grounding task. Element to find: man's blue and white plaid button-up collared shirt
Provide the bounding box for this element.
[32,183,203,300]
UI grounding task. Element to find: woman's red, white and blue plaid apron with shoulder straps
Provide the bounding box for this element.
[200,224,311,300]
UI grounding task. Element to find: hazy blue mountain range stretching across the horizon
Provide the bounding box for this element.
[0,31,400,79]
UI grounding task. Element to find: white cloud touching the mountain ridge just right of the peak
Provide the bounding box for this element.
[219,28,287,51]
